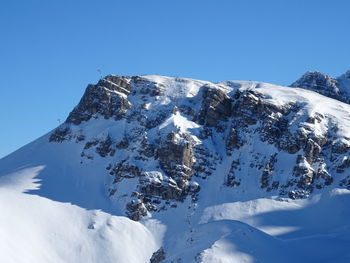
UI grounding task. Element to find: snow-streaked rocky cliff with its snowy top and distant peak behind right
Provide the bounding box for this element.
[49,72,350,227]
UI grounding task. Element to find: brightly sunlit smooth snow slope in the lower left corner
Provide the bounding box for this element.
[0,161,159,263]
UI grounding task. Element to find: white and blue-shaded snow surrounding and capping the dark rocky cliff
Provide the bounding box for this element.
[0,76,350,263]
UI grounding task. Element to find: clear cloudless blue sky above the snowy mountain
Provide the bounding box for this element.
[0,0,350,157]
